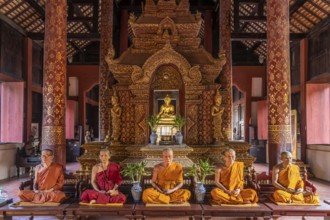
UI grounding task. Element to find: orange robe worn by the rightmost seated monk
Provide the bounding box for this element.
[273,164,319,204]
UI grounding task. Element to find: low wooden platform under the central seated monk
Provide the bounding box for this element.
[135,203,203,219]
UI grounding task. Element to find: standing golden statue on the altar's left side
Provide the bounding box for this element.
[111,91,122,144]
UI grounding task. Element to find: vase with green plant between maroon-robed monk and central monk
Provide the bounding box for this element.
[121,161,146,202]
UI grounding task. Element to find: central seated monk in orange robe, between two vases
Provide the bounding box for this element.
[142,148,191,204]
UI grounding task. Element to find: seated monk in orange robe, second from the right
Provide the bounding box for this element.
[211,148,258,204]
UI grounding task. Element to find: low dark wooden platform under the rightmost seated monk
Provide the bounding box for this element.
[264,200,330,219]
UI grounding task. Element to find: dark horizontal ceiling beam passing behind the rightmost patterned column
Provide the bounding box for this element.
[231,33,306,41]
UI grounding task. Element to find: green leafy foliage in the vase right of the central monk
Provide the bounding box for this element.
[186,159,215,184]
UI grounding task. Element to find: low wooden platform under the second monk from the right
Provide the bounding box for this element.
[202,203,272,220]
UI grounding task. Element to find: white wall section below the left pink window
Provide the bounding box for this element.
[0,143,22,180]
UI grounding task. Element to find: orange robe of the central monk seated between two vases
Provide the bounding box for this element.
[142,163,191,204]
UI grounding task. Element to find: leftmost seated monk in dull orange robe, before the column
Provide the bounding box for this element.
[18,149,65,203]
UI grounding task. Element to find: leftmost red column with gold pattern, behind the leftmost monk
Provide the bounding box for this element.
[41,0,67,166]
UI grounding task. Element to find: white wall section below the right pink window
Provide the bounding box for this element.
[307,145,330,181]
